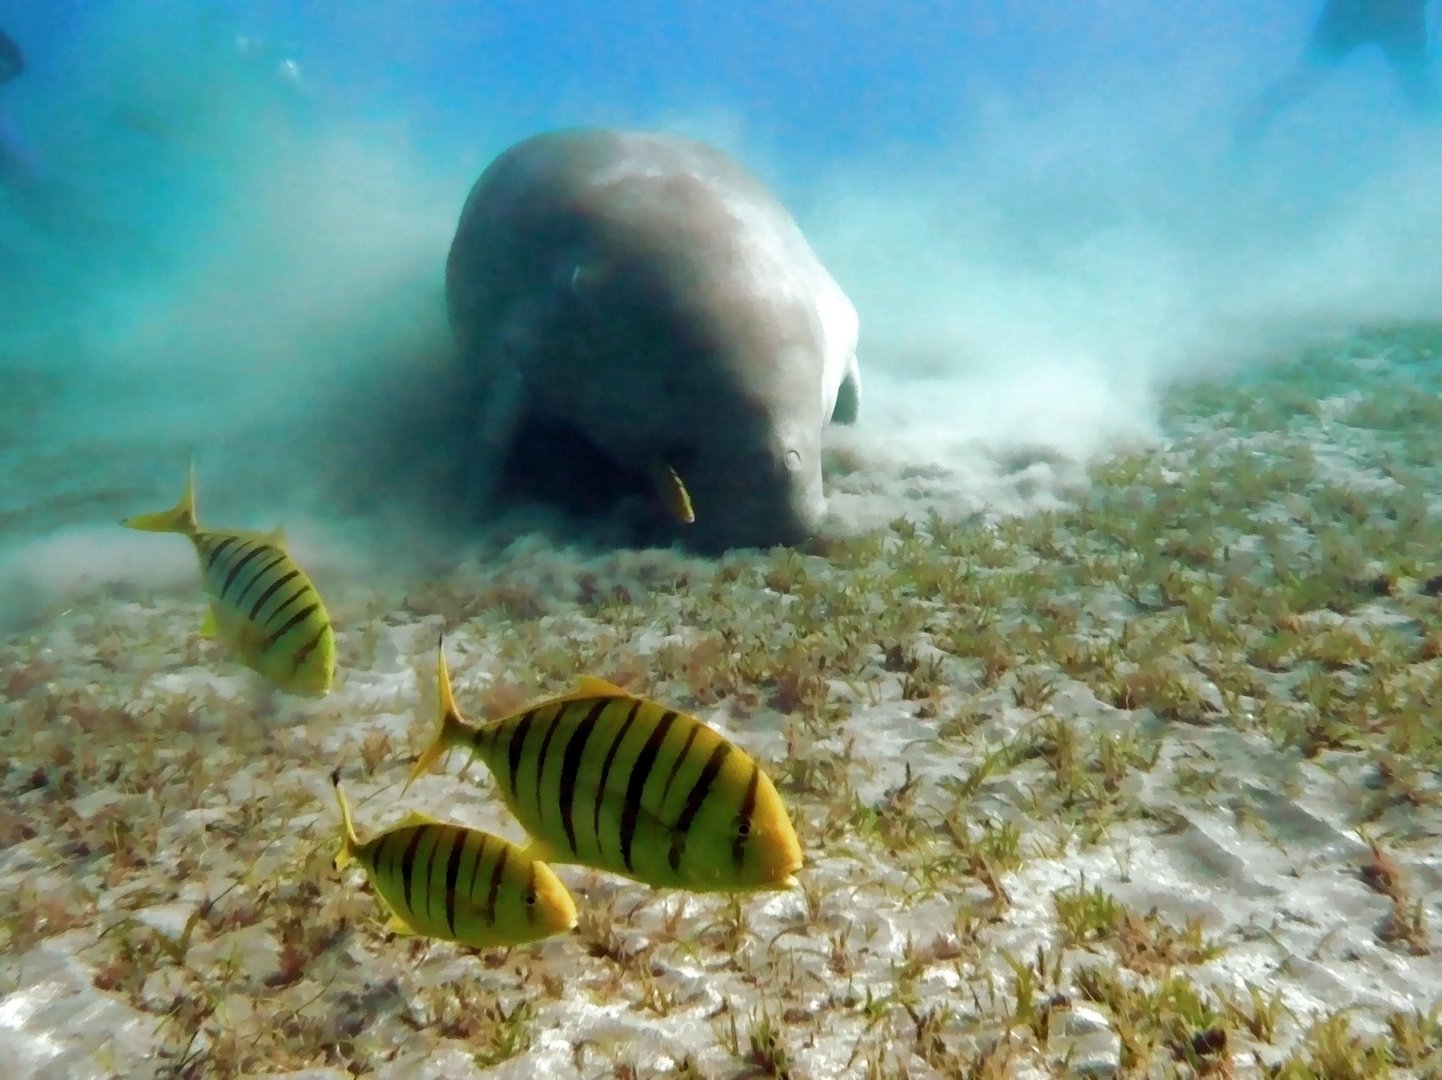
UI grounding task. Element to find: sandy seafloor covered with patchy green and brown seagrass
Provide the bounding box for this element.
[0,327,1442,1080]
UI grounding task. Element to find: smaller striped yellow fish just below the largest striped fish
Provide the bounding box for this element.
[330,770,575,949]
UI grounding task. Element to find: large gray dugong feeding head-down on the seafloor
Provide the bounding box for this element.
[446,130,861,548]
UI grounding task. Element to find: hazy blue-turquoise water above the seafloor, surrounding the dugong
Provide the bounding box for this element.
[0,0,1442,542]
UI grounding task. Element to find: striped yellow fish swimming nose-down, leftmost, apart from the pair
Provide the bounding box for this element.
[121,466,336,696]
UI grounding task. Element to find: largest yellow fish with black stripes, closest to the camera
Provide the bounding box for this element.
[407,652,802,893]
